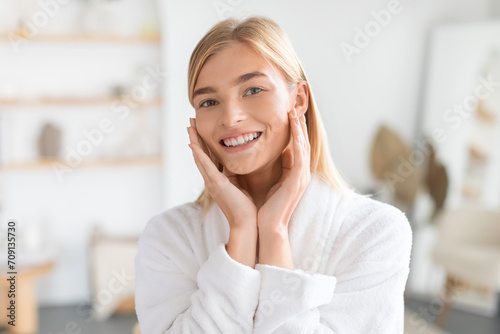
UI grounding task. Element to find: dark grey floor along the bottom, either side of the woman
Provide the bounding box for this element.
[5,298,494,334]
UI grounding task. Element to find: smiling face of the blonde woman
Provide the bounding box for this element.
[193,43,294,174]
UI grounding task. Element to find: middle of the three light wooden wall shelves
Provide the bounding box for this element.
[0,97,162,108]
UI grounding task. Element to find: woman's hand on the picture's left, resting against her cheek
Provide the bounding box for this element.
[188,118,257,232]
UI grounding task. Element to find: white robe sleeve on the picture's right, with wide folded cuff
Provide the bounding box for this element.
[254,206,412,334]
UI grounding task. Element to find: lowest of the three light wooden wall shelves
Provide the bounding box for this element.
[0,157,162,172]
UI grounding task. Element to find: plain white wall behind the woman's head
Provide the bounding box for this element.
[159,0,491,207]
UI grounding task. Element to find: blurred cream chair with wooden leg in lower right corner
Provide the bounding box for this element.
[432,207,500,328]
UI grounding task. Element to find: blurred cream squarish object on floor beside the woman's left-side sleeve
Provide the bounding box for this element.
[90,228,139,321]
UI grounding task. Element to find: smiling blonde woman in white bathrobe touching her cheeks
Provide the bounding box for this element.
[136,17,412,334]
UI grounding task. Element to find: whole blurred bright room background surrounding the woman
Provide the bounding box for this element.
[0,0,500,334]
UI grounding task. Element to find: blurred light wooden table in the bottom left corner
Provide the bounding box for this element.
[0,262,54,334]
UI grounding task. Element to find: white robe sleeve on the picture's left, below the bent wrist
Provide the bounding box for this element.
[135,211,261,334]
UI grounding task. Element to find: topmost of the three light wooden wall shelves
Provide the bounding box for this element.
[0,32,161,44]
